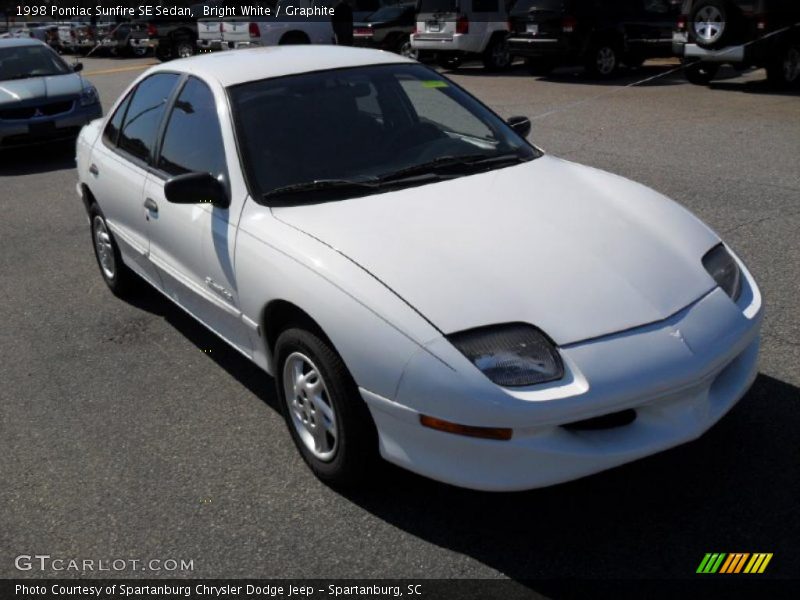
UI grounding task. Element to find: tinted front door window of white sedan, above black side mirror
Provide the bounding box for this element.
[158,77,225,177]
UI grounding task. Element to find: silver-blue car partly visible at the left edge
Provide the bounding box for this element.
[0,39,103,149]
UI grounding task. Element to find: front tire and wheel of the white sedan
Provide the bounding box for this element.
[275,327,378,485]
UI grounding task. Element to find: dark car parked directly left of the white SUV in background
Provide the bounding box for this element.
[353,3,417,58]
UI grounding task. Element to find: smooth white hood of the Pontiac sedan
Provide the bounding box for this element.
[273,156,719,345]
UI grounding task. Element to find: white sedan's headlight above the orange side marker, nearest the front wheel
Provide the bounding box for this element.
[447,323,564,387]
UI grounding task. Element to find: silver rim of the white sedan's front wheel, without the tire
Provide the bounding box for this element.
[283,352,339,461]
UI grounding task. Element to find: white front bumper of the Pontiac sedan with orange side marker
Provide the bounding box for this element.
[361,255,762,491]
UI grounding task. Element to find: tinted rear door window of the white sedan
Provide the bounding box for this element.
[119,73,178,161]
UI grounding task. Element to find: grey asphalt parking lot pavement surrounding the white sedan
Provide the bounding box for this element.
[0,52,800,591]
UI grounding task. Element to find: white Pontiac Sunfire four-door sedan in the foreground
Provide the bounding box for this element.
[77,46,762,490]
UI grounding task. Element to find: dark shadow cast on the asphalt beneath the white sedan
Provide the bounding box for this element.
[117,290,800,598]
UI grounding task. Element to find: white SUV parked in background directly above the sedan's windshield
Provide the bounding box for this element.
[411,0,513,71]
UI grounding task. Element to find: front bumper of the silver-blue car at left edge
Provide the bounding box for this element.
[0,100,103,148]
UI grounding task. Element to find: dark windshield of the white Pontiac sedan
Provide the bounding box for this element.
[230,64,539,203]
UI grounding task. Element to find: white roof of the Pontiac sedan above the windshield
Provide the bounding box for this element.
[151,45,414,87]
